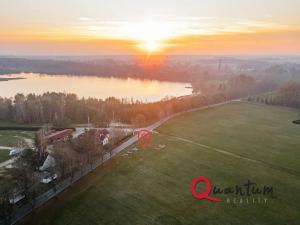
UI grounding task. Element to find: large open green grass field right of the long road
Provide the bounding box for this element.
[23,103,300,225]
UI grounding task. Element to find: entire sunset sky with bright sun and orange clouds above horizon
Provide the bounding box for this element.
[0,0,300,55]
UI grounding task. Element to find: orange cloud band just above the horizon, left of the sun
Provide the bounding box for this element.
[0,38,138,55]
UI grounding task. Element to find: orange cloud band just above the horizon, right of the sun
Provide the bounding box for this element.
[168,30,300,54]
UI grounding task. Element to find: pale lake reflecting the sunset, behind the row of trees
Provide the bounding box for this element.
[0,73,192,102]
